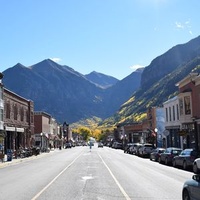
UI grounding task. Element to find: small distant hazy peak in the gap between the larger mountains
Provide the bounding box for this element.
[85,71,119,88]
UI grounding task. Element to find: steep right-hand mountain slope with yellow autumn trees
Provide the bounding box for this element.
[106,37,200,124]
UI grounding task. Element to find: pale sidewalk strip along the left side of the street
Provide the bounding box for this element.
[0,149,58,169]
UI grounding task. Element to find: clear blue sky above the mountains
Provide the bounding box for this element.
[0,0,200,80]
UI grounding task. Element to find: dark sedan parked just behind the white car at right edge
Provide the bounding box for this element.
[172,149,198,169]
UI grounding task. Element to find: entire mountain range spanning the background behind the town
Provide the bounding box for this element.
[3,36,200,125]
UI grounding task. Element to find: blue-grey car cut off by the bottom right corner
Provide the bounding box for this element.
[182,174,200,200]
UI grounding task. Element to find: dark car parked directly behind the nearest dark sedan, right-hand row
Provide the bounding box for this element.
[158,147,182,165]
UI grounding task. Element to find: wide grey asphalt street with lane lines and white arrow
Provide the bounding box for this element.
[0,144,193,200]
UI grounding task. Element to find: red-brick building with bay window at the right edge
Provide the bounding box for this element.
[177,73,200,150]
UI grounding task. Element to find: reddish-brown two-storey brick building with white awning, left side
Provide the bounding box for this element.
[3,88,34,152]
